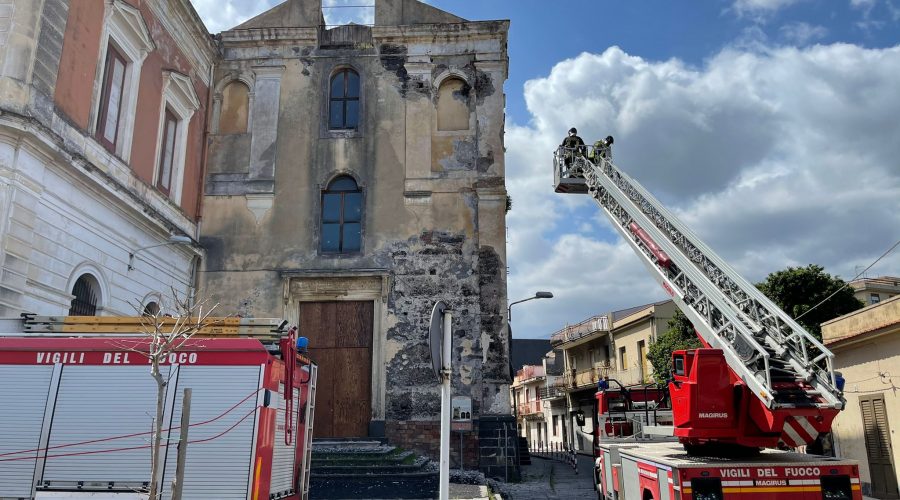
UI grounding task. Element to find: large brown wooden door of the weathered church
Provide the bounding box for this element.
[300,302,374,438]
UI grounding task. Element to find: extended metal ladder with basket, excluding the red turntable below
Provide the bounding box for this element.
[554,147,844,410]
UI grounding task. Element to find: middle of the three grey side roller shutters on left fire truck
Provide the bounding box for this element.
[43,364,169,489]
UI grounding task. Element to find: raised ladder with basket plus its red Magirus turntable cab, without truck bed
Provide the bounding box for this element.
[554,142,845,454]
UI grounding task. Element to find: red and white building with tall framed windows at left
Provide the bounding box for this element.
[0,0,216,316]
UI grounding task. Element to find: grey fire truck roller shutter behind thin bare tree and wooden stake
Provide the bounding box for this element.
[163,365,261,500]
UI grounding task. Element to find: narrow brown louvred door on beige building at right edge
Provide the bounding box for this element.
[859,394,900,498]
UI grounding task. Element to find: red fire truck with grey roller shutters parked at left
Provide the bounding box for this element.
[0,318,316,500]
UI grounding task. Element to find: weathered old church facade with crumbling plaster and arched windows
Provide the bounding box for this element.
[201,0,515,475]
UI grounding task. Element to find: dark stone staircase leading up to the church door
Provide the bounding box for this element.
[309,439,438,500]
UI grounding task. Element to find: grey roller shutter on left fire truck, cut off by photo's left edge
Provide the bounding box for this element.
[0,365,53,498]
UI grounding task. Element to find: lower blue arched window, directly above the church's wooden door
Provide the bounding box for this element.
[322,175,362,253]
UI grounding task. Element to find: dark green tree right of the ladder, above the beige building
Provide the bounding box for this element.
[756,264,864,340]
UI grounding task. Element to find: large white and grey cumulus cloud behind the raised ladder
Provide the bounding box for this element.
[506,44,900,336]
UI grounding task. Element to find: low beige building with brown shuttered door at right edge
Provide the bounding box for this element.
[822,296,900,498]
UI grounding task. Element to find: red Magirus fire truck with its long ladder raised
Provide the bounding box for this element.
[554,140,862,500]
